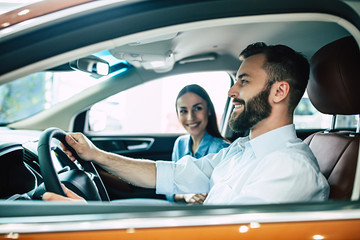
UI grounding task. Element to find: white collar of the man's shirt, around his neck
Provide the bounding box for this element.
[249,124,297,158]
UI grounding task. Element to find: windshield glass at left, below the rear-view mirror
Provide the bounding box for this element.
[0,71,105,125]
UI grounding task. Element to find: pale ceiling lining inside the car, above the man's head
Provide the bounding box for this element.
[110,17,349,72]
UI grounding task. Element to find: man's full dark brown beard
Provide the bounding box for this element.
[229,86,271,132]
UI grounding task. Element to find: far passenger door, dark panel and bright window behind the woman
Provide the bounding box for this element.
[74,72,232,199]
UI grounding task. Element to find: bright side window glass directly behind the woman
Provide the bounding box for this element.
[88,72,231,135]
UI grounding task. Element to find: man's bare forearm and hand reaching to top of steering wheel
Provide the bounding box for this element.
[62,133,156,188]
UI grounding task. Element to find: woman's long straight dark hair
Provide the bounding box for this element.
[175,84,226,140]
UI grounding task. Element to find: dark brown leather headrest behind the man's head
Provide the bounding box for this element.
[307,37,360,115]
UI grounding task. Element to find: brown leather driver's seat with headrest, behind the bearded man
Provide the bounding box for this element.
[305,37,360,200]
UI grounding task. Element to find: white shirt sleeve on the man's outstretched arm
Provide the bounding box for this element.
[156,149,226,194]
